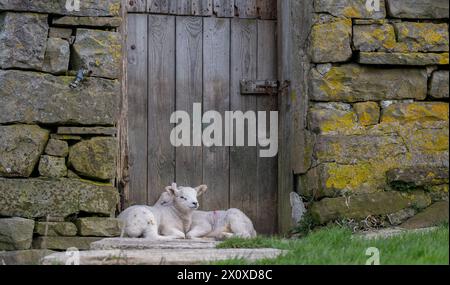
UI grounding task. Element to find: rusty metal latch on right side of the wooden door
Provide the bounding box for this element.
[241,80,290,95]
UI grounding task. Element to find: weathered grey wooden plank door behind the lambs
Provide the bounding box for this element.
[125,0,277,234]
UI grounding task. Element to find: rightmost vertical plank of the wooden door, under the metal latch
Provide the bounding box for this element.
[256,20,278,234]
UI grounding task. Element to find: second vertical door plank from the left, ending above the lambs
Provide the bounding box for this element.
[148,15,175,205]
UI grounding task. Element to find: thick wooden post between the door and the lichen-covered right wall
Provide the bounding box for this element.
[278,0,313,234]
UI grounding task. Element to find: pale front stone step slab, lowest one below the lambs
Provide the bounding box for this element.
[42,248,286,265]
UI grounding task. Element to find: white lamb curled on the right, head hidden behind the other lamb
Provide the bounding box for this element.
[159,192,257,240]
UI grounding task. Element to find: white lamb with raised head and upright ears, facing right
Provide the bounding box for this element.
[118,183,207,240]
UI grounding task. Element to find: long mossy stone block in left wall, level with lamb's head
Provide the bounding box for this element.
[0,178,119,218]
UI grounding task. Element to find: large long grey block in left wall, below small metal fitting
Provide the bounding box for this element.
[0,70,120,125]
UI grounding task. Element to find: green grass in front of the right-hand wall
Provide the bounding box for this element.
[215,225,449,265]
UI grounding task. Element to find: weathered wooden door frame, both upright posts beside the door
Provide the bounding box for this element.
[116,0,313,234]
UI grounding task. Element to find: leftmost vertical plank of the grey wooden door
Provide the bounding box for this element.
[127,14,148,205]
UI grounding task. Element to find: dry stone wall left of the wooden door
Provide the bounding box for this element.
[0,0,123,256]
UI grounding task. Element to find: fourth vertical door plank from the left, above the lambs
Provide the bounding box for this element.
[202,18,230,210]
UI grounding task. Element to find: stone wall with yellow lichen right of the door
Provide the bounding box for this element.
[297,0,449,227]
